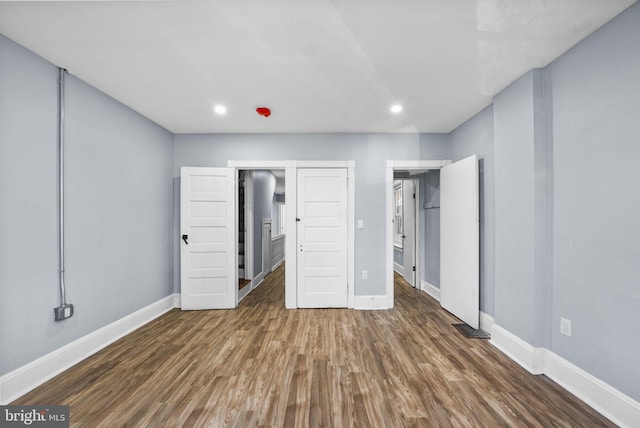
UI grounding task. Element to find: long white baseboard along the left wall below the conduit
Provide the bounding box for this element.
[0,294,180,405]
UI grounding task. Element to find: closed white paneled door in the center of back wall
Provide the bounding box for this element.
[296,169,348,308]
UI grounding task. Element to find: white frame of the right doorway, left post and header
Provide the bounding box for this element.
[385,160,451,308]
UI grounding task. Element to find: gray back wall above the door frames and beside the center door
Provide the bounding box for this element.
[174,134,449,295]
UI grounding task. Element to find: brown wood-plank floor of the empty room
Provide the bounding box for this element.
[12,268,614,427]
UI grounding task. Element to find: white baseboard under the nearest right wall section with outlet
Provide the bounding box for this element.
[544,350,640,427]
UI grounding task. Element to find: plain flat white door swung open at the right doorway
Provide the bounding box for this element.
[440,155,480,329]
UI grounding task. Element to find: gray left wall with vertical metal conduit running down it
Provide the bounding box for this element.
[0,36,172,375]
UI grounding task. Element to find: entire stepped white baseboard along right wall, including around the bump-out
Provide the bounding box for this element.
[490,324,640,427]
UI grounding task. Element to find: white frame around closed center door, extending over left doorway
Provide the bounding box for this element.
[227,160,358,309]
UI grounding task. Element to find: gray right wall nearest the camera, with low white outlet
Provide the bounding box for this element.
[549,3,640,400]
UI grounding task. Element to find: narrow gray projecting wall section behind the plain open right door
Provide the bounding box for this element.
[493,72,542,346]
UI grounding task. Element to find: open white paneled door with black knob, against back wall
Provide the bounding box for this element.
[180,167,238,309]
